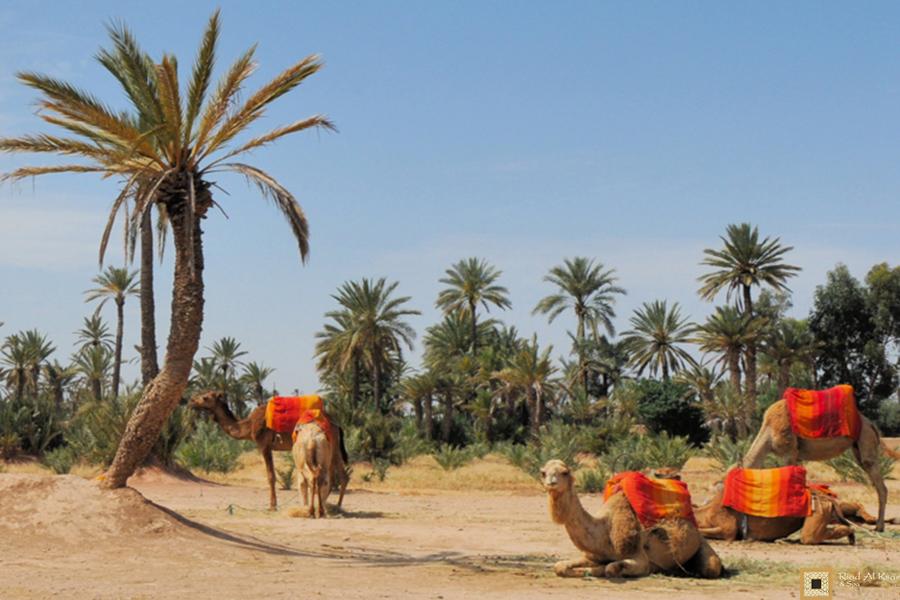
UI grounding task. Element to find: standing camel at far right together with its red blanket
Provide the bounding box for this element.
[741,385,900,531]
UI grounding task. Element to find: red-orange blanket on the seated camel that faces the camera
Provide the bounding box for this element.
[603,471,697,527]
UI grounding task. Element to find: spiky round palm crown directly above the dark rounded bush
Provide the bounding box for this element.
[622,300,695,381]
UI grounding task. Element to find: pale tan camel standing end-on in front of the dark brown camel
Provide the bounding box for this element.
[292,422,331,517]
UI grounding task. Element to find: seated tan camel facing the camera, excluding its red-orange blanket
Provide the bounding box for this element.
[541,460,722,578]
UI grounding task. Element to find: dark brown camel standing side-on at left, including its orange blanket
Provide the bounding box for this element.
[190,391,348,510]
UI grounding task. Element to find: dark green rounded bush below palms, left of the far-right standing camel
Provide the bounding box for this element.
[632,379,709,445]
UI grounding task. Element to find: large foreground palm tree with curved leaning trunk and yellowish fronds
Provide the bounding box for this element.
[0,11,332,487]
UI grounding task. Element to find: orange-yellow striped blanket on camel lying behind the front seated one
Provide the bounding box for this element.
[722,466,810,518]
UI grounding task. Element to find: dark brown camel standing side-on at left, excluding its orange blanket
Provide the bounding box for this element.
[190,391,348,510]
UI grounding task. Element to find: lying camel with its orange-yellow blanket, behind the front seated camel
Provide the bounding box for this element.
[694,466,856,544]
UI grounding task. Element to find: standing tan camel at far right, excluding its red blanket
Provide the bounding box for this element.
[741,399,900,531]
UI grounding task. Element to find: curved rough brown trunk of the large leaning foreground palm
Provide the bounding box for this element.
[106,197,209,488]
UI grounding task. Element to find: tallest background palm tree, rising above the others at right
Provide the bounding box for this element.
[698,223,800,402]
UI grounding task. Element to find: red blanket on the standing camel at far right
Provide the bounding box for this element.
[784,385,861,440]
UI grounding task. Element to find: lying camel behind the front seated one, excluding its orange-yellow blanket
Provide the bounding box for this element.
[694,481,856,545]
